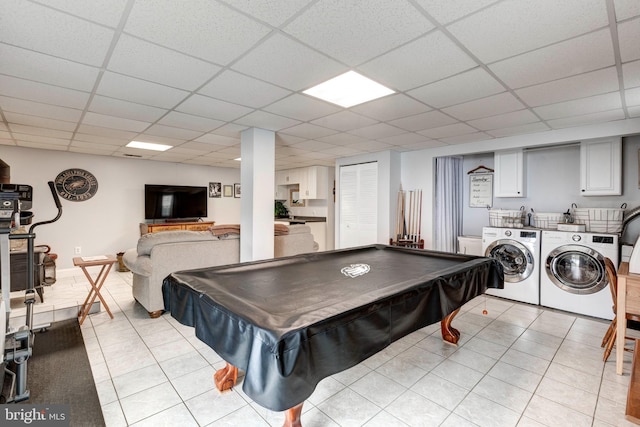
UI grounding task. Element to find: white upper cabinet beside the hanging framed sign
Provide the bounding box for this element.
[493,150,525,197]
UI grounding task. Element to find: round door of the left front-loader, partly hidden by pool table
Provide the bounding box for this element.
[485,239,535,283]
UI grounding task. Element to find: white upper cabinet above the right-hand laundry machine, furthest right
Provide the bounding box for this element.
[580,138,622,196]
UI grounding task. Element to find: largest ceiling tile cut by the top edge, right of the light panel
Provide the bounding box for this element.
[447,0,608,62]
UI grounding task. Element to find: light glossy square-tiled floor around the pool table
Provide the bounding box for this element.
[12,269,634,427]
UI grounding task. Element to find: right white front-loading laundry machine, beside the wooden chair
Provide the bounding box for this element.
[540,230,619,320]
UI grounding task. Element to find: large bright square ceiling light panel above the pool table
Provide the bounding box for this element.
[303,71,395,108]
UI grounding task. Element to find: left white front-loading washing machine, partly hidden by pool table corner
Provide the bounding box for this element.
[482,227,541,305]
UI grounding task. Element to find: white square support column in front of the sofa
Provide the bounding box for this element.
[240,128,276,262]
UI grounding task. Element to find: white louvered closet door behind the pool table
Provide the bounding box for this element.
[339,162,378,248]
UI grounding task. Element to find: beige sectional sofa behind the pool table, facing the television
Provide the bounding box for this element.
[122,225,318,317]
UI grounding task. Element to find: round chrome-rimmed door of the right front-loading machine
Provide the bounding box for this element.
[546,245,609,295]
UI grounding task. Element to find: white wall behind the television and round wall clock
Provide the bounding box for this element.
[0,146,241,268]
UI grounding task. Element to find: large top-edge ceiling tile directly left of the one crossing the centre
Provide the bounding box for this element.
[125,0,270,65]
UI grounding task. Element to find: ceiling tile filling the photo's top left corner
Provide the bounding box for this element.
[0,0,114,66]
